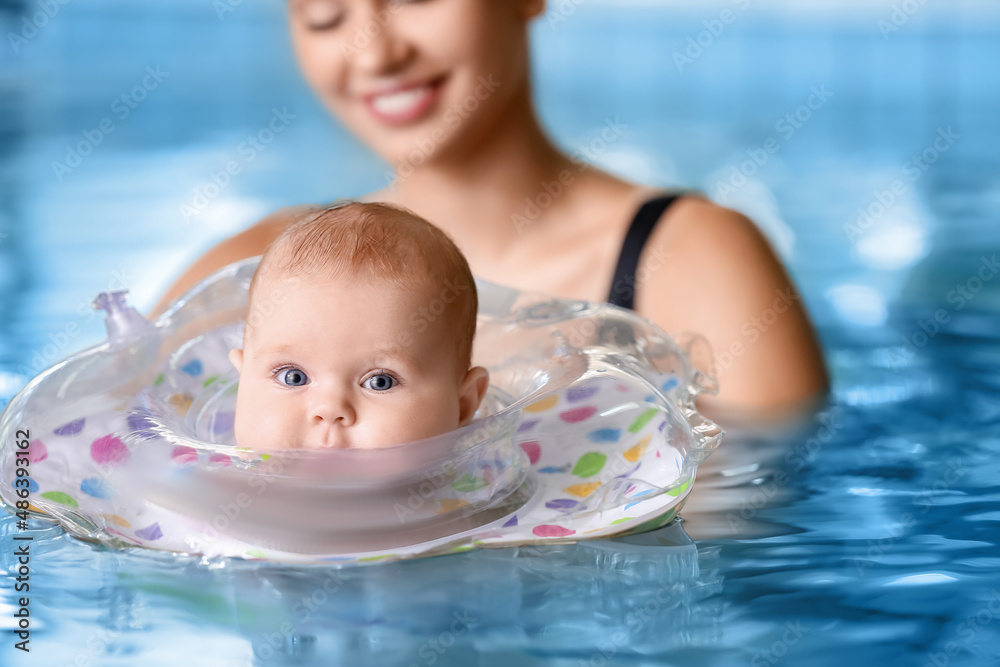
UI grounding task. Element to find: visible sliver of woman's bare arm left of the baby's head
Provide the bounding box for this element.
[150,206,313,318]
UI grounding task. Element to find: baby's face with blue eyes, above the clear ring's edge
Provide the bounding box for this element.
[230,277,488,449]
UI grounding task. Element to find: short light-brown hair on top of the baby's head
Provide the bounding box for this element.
[247,202,479,373]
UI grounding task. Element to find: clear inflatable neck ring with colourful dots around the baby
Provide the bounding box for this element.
[0,258,723,564]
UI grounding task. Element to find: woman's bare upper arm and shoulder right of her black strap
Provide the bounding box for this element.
[636,198,829,416]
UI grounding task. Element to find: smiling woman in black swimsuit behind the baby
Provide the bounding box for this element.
[154,0,827,415]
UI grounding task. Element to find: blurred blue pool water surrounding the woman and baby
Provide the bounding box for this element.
[0,0,1000,667]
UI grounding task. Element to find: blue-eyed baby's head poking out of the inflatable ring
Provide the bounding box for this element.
[229,203,489,449]
